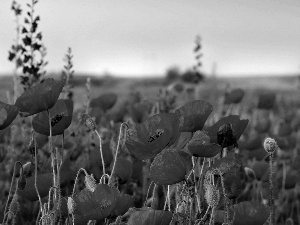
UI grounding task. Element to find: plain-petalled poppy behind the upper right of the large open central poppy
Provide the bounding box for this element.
[175,100,213,132]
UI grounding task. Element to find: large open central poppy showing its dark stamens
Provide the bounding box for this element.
[126,113,179,160]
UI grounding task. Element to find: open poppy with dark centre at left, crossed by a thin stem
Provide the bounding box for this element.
[32,99,73,136]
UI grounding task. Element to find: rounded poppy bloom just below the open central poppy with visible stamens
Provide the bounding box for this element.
[150,148,192,185]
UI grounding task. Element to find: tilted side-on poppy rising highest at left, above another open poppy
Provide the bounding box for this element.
[15,78,65,116]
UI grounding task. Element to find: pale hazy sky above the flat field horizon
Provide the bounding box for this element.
[0,0,300,76]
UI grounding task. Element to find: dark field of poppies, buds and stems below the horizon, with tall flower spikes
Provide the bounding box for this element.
[0,0,300,225]
